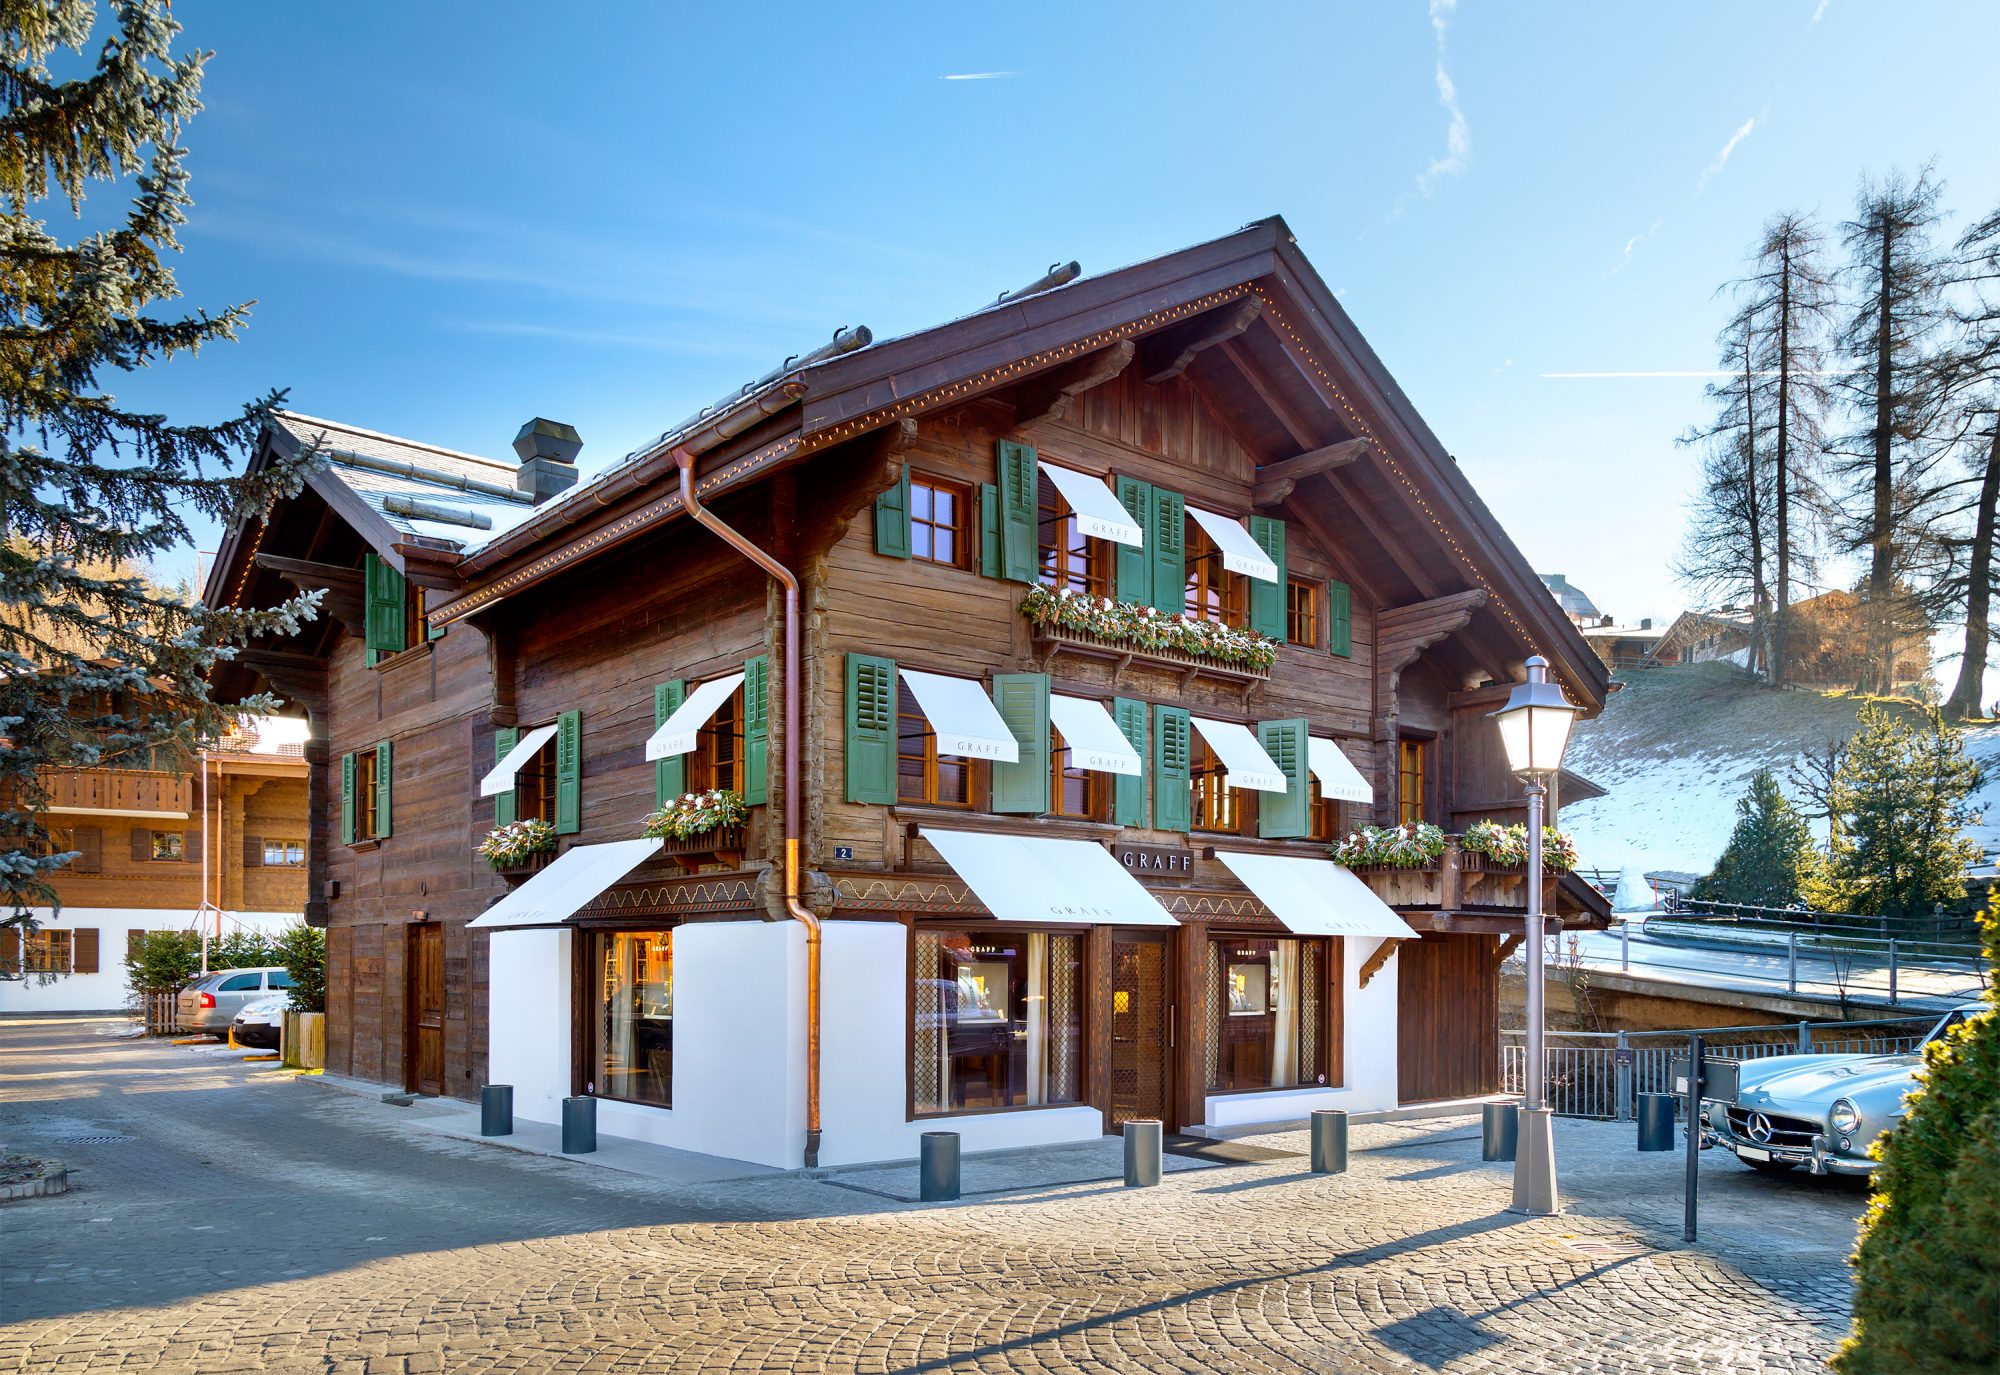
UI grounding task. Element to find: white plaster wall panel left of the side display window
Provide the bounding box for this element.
[486,927,574,1123]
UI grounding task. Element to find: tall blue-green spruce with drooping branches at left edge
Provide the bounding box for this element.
[0,0,314,925]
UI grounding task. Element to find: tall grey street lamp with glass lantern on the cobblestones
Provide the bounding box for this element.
[1494,654,1576,1215]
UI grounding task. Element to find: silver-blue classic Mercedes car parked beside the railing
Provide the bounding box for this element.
[1702,1003,1984,1175]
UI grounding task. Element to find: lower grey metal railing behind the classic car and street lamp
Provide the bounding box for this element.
[1500,1015,1938,1121]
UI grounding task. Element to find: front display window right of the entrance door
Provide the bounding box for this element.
[1208,935,1330,1093]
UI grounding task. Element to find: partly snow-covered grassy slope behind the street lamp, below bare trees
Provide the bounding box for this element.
[1562,664,2000,873]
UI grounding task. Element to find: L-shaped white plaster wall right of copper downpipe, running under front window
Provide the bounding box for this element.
[820,921,1104,1165]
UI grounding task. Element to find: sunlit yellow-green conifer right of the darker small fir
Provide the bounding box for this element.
[1808,701,1980,917]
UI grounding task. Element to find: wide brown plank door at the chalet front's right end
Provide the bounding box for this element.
[1396,931,1500,1103]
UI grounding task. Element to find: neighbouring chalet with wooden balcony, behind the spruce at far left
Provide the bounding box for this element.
[0,721,306,1011]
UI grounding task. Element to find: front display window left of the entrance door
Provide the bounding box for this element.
[910,929,1086,1117]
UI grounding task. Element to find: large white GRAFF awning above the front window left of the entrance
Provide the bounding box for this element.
[918,825,1178,925]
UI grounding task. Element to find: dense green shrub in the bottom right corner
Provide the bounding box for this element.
[1832,909,2000,1375]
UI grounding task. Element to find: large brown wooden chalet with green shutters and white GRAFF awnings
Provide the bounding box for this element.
[206,220,1606,1165]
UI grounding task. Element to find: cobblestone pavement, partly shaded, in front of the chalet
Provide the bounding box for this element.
[0,1019,1864,1375]
